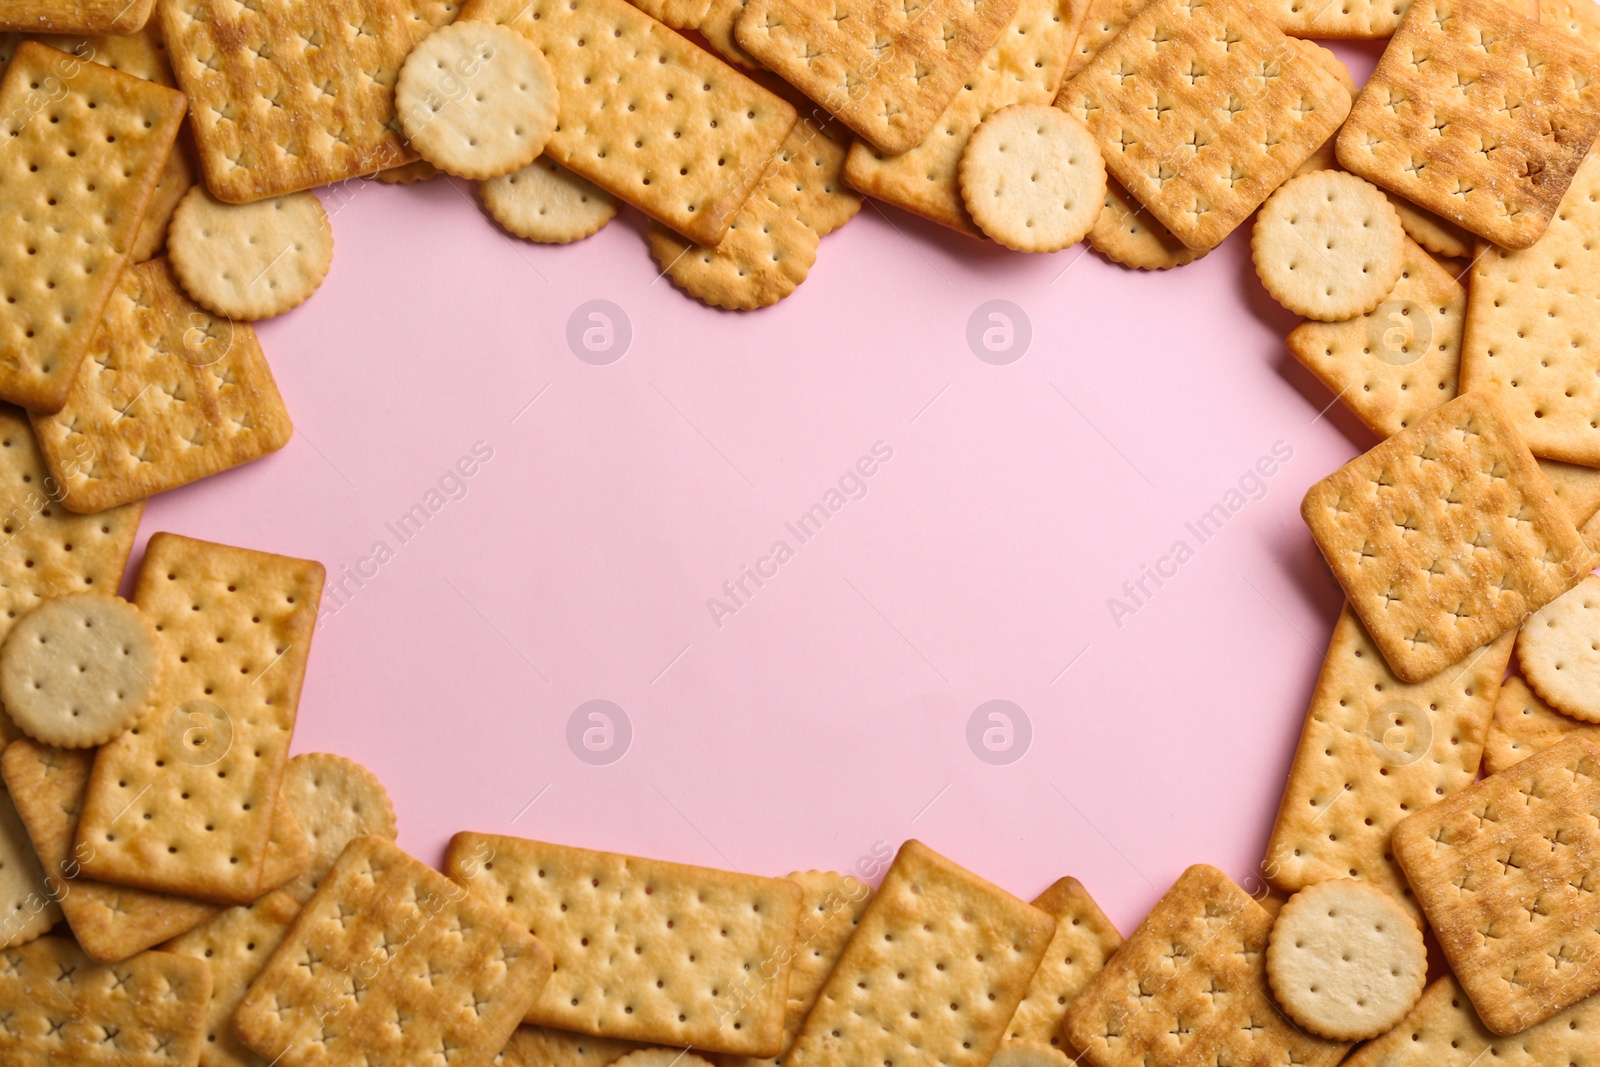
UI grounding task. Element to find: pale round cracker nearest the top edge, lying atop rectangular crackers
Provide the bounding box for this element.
[395,21,558,181]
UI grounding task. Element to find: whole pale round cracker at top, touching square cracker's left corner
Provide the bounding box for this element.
[960,104,1106,253]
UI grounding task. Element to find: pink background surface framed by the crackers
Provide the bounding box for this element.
[136,39,1401,931]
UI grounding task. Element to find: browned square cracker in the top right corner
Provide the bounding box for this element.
[1339,0,1600,248]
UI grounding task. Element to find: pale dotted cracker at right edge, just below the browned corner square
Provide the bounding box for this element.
[1461,147,1600,466]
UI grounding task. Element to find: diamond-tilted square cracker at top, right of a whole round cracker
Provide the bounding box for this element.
[1056,0,1350,251]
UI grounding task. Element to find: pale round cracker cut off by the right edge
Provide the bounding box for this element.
[1517,574,1600,723]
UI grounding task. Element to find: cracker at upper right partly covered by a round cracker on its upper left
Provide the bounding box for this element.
[1288,240,1467,437]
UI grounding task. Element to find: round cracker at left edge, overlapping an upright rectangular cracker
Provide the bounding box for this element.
[0,593,162,749]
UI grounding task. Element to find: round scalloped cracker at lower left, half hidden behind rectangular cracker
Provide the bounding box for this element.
[283,752,398,904]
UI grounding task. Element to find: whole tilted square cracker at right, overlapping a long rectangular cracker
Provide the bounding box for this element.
[1301,392,1594,681]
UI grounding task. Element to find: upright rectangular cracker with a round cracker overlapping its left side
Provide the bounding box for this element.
[77,533,323,904]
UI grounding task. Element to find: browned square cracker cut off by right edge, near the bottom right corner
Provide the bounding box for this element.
[1394,736,1600,1035]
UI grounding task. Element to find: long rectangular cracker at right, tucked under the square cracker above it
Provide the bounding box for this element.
[1262,605,1517,917]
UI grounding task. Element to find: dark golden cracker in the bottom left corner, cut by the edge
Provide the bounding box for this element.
[0,937,211,1067]
